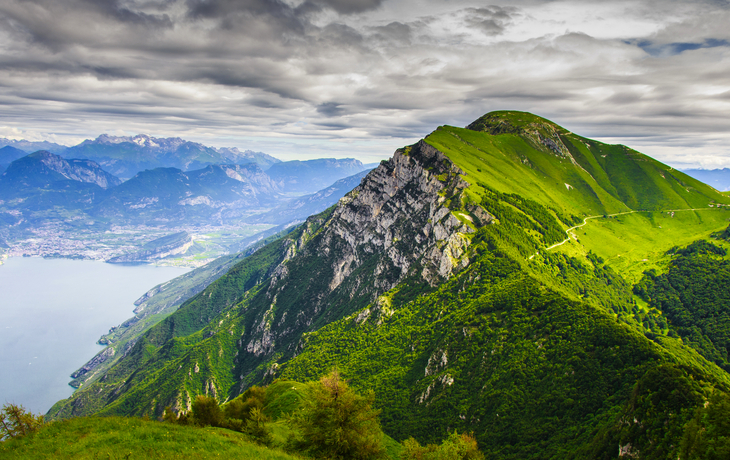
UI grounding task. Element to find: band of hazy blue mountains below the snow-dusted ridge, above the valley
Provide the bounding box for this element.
[0,147,366,228]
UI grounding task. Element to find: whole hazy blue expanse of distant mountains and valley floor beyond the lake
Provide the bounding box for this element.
[0,135,372,266]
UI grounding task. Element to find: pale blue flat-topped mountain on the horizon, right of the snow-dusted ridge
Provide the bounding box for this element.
[266,158,369,194]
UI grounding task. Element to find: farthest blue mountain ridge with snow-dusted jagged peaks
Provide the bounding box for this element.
[63,134,279,177]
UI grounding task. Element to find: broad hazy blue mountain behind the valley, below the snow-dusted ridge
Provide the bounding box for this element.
[90,163,280,225]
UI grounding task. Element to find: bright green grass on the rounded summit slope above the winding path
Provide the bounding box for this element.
[425,118,730,221]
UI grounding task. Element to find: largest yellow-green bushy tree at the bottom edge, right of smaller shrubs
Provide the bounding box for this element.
[289,370,385,459]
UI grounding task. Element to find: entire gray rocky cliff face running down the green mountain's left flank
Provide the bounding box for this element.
[241,141,474,362]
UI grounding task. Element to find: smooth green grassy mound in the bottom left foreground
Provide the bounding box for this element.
[0,417,299,460]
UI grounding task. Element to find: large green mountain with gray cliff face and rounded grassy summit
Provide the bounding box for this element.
[48,112,730,459]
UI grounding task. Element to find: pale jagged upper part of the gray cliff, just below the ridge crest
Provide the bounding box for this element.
[323,141,472,290]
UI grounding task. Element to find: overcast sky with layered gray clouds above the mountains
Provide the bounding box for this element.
[0,0,730,165]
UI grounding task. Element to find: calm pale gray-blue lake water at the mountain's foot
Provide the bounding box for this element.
[0,257,190,413]
